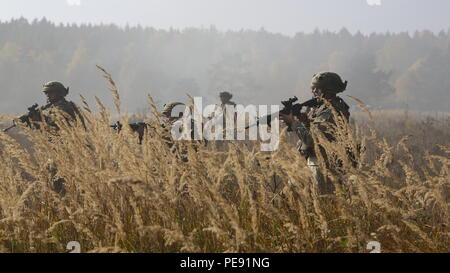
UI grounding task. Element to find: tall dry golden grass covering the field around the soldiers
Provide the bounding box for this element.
[0,75,450,252]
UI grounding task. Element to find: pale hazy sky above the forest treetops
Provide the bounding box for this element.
[0,0,450,35]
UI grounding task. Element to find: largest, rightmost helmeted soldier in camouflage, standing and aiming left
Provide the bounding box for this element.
[280,72,350,194]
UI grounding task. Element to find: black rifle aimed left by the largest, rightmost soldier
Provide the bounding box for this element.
[245,97,321,131]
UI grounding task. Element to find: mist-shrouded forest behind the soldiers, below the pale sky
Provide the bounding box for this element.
[0,18,450,113]
